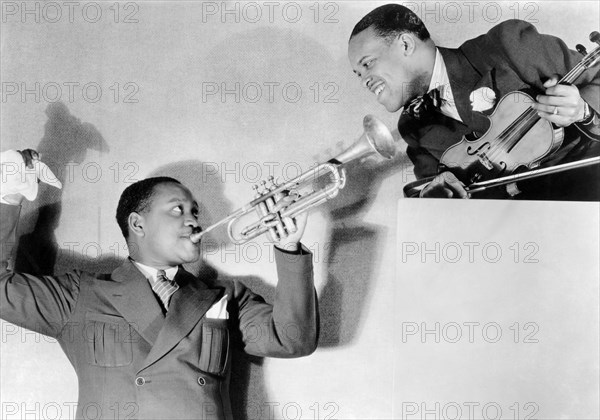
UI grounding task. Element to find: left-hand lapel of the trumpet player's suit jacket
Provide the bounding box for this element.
[103,259,165,345]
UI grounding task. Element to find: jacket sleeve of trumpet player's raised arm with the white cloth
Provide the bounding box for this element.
[0,204,80,338]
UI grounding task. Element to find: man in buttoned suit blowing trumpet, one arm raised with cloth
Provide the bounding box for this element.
[0,150,318,419]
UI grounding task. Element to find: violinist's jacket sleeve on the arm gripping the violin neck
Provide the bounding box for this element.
[486,20,600,139]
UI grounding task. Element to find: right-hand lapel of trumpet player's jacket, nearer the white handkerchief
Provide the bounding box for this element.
[140,268,222,370]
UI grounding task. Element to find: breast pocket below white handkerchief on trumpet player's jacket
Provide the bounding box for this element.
[198,319,229,375]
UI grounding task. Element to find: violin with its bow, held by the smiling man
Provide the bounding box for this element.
[404,32,600,197]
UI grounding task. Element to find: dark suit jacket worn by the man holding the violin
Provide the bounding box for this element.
[398,20,600,199]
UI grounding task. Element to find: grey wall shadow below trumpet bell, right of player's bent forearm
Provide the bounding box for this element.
[319,145,409,347]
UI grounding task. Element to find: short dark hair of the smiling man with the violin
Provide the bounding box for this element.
[350,4,430,43]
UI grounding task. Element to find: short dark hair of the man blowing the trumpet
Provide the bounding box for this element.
[117,176,181,239]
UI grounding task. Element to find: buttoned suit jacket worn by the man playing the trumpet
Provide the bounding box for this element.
[0,204,318,419]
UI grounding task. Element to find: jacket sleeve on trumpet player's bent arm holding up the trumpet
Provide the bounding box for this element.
[234,248,319,358]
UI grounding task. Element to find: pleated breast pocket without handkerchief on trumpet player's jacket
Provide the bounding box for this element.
[84,313,133,367]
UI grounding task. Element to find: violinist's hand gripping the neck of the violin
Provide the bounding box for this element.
[532,75,585,127]
